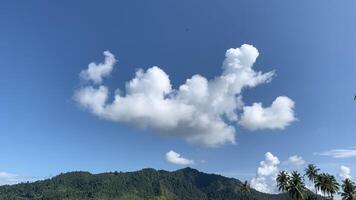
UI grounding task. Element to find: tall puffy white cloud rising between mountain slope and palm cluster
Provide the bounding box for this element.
[251,152,280,193]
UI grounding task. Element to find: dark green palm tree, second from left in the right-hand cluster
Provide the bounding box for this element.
[287,171,306,200]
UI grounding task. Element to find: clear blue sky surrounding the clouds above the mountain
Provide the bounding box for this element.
[0,0,356,193]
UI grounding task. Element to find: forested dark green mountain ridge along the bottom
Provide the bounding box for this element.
[0,168,322,200]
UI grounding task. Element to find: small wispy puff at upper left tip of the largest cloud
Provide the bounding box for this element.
[79,51,116,84]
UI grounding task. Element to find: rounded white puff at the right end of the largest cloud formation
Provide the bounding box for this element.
[239,96,296,130]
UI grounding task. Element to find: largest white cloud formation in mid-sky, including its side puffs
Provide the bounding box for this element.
[74,44,295,147]
